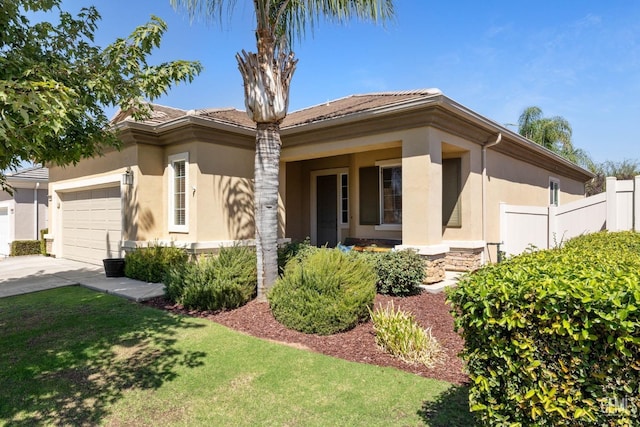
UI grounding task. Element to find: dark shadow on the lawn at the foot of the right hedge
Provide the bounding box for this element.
[418,385,477,427]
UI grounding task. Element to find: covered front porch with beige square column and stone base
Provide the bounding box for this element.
[280,127,484,283]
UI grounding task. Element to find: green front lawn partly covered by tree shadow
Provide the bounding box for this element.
[0,287,472,426]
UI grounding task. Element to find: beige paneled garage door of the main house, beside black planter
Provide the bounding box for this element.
[60,187,122,264]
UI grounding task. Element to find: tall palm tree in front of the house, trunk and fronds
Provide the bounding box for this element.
[170,0,394,300]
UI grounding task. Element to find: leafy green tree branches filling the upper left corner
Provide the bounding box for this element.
[0,0,202,189]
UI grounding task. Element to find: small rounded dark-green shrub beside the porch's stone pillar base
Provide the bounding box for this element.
[375,250,426,296]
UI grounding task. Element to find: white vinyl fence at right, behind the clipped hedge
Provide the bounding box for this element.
[500,176,640,255]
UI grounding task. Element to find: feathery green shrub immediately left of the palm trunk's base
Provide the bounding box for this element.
[165,247,257,311]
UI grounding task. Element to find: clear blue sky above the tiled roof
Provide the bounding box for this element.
[58,0,640,165]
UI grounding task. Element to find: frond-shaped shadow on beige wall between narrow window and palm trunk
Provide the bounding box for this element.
[214,176,255,240]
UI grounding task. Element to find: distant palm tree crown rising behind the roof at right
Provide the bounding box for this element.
[518,106,575,154]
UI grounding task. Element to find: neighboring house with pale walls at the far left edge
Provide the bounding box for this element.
[0,166,49,256]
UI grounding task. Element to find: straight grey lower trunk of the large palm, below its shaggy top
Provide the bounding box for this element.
[254,123,281,301]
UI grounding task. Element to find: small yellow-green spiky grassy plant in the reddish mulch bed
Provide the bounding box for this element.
[370,301,442,367]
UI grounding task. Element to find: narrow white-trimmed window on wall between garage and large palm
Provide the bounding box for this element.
[169,153,189,232]
